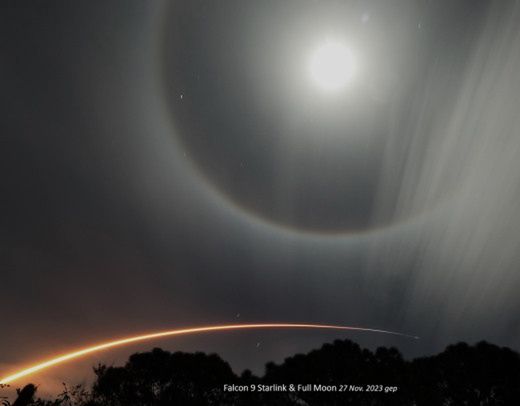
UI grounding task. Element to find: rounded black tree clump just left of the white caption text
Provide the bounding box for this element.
[92,348,238,406]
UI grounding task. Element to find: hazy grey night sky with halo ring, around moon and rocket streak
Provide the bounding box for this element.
[0,0,520,394]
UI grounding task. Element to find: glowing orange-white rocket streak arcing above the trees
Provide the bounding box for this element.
[0,323,419,385]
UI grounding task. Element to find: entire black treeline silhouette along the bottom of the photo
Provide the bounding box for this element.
[4,340,520,406]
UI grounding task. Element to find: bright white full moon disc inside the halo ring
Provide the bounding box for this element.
[309,41,354,92]
